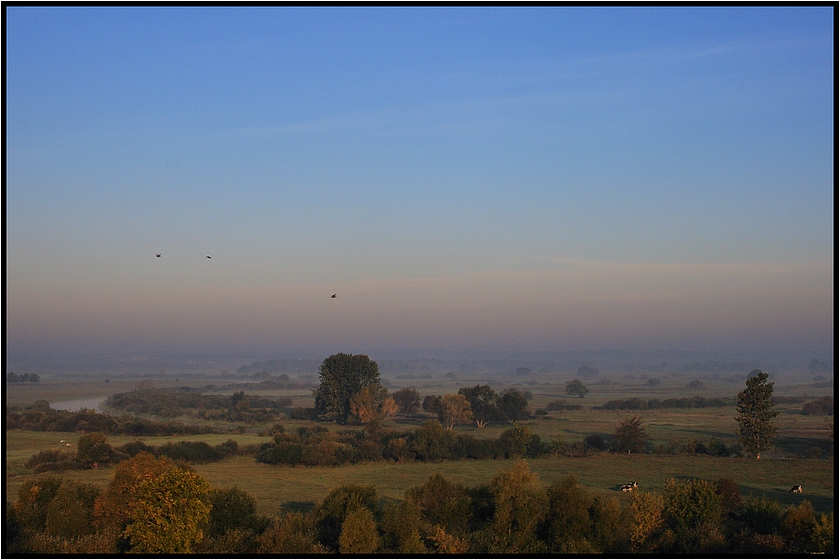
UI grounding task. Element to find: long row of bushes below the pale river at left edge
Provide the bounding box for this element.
[5,401,216,436]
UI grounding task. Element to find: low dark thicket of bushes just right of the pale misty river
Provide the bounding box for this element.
[105,387,292,423]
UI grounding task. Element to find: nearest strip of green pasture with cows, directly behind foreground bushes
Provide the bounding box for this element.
[6,432,834,514]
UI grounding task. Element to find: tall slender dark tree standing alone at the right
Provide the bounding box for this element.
[735,369,779,459]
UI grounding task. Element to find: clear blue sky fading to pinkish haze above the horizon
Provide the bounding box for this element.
[5,6,836,357]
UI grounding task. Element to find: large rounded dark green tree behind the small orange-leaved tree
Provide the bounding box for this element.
[314,354,381,424]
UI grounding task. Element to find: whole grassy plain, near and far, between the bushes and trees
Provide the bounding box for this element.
[5,368,836,514]
